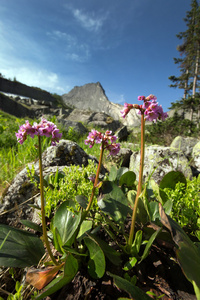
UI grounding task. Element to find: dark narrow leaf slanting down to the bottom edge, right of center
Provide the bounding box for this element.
[107,272,152,300]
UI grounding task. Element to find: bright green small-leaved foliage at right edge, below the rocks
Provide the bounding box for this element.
[164,176,200,240]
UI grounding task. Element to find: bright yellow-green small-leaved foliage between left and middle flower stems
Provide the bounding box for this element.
[45,161,97,216]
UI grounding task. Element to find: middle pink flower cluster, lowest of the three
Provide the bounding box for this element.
[85,129,120,155]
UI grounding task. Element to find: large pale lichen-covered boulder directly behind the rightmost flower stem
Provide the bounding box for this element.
[129,145,192,184]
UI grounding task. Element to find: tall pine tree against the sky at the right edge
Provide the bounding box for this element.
[169,0,200,121]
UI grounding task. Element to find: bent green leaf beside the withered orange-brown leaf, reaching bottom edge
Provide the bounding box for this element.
[34,254,78,300]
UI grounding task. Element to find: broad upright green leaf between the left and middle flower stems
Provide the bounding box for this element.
[52,201,81,246]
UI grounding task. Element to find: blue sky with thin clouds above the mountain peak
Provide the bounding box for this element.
[0,0,190,110]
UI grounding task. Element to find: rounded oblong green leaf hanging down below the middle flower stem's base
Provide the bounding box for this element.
[84,236,106,279]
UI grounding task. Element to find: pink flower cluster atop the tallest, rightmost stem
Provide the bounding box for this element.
[121,94,168,122]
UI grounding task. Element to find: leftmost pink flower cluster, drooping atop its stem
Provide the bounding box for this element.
[15,118,62,146]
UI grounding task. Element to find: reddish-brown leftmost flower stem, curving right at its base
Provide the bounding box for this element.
[38,135,58,265]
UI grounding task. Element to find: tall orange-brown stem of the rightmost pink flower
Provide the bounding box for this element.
[127,111,145,251]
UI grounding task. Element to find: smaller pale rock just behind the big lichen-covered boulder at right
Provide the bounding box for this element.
[170,136,199,157]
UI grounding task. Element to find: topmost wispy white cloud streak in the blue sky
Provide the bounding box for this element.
[71,9,107,32]
